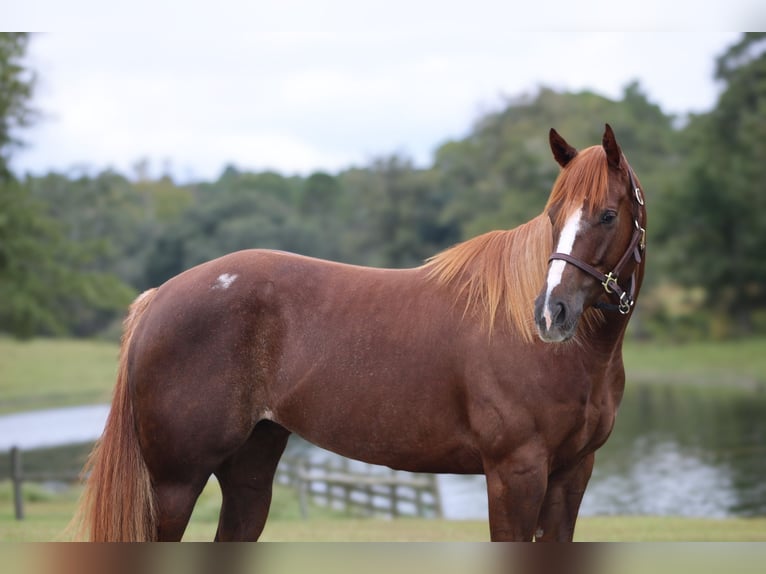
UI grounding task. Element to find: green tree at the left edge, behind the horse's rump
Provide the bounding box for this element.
[0,34,133,337]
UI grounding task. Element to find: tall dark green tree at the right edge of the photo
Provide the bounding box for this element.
[661,33,766,331]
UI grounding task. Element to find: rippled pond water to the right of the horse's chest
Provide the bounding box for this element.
[582,385,766,517]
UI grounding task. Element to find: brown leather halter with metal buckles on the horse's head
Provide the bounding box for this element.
[548,164,646,315]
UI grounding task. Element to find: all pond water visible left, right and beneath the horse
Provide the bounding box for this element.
[0,384,766,519]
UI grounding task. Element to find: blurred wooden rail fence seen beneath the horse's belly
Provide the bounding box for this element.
[275,457,442,518]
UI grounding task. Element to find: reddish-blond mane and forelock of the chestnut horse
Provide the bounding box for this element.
[425,146,608,342]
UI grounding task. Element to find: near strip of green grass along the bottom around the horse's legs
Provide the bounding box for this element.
[0,482,766,542]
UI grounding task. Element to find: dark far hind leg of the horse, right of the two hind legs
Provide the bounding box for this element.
[215,421,290,541]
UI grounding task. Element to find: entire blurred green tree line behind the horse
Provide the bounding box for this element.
[0,33,766,338]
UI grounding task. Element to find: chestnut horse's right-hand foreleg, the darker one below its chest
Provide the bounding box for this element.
[535,453,595,542]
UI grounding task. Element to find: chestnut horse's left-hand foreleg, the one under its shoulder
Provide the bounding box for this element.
[485,451,548,542]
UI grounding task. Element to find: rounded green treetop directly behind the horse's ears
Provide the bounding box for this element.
[435,82,679,241]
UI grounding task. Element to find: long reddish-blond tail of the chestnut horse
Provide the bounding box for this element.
[70,289,157,542]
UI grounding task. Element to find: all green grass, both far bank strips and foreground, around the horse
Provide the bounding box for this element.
[0,338,766,541]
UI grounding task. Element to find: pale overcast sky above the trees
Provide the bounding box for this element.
[0,0,766,181]
